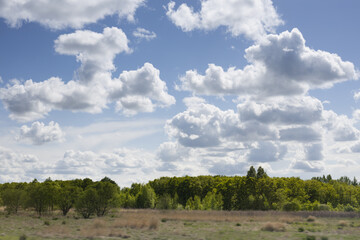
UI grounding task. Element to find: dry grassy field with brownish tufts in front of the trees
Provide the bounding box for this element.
[0,209,360,240]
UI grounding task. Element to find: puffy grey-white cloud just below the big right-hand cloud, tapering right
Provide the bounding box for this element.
[165,98,277,147]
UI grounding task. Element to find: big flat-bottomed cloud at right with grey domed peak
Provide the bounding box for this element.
[179,29,358,98]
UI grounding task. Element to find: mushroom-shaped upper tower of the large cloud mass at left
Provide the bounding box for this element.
[55,27,131,82]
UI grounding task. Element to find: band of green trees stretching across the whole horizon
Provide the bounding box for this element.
[0,167,360,218]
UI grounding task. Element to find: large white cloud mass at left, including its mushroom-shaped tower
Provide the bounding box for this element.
[0,28,175,122]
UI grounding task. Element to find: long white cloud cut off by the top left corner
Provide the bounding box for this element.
[0,0,145,29]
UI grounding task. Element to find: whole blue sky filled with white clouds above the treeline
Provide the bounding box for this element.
[0,0,360,187]
